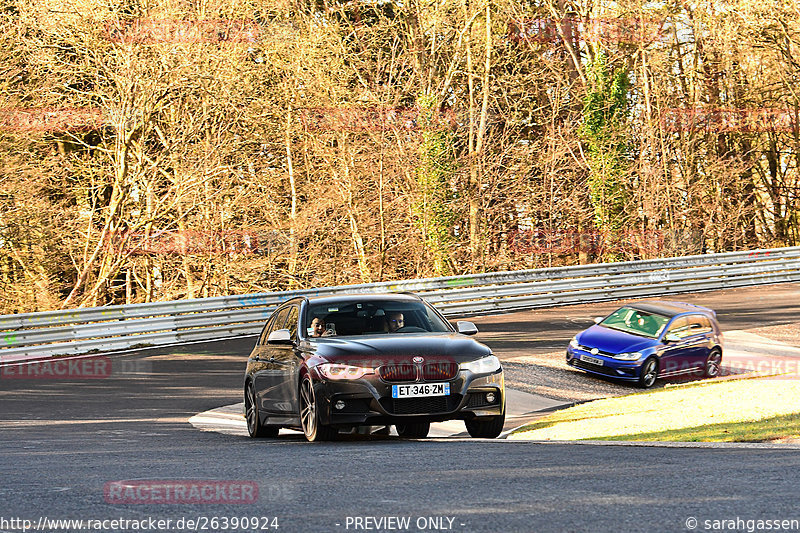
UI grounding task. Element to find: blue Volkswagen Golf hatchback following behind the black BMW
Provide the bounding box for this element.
[567,302,722,388]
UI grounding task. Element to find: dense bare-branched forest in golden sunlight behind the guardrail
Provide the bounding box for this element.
[0,0,800,313]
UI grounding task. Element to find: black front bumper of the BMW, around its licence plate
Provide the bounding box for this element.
[314,369,506,428]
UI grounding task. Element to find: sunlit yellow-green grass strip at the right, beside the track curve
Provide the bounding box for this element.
[509,377,800,441]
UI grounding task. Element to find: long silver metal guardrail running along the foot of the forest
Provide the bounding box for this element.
[0,246,800,363]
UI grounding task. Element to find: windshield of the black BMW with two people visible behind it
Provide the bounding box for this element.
[305,300,452,337]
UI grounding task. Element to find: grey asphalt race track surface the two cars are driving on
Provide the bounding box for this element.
[0,285,800,532]
